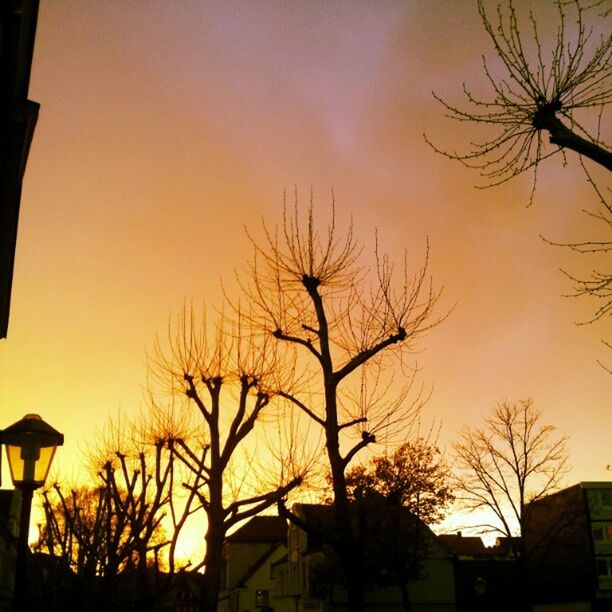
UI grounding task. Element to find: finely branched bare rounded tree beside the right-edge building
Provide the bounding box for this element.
[454,400,568,608]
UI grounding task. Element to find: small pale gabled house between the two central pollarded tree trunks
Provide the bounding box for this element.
[219,516,287,612]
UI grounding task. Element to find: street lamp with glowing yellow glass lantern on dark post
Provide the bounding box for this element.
[0,414,64,612]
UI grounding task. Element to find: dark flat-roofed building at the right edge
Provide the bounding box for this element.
[525,482,612,612]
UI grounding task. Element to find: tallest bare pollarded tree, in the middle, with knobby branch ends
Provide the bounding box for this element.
[242,201,440,612]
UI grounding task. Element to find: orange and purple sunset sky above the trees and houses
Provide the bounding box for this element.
[0,0,612,512]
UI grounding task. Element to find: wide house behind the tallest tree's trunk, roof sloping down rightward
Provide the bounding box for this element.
[276,504,455,612]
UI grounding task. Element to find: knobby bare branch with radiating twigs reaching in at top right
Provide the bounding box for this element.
[428,0,612,194]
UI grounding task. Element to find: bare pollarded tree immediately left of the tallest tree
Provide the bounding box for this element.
[152,310,303,612]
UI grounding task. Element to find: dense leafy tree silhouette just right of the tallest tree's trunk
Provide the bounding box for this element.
[346,438,454,612]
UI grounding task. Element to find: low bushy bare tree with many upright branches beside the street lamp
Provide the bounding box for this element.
[35,432,189,610]
